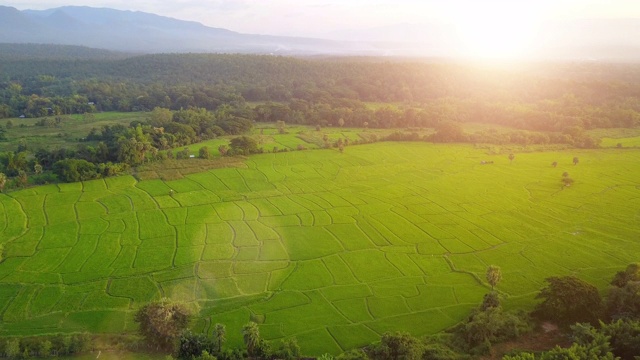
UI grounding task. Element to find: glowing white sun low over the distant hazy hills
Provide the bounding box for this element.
[454,2,538,59]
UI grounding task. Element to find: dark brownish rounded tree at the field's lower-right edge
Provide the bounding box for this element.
[533,276,603,326]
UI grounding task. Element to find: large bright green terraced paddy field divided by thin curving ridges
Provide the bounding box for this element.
[0,143,640,355]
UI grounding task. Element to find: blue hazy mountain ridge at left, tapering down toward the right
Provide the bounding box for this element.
[0,6,375,54]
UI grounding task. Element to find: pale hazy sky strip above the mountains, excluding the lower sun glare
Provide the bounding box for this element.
[2,0,640,36]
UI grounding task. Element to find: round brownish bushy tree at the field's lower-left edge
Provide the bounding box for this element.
[134,299,191,352]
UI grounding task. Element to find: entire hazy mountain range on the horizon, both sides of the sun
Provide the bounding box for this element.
[0,6,640,61]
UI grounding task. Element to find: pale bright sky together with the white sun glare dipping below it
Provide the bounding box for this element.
[3,0,640,58]
